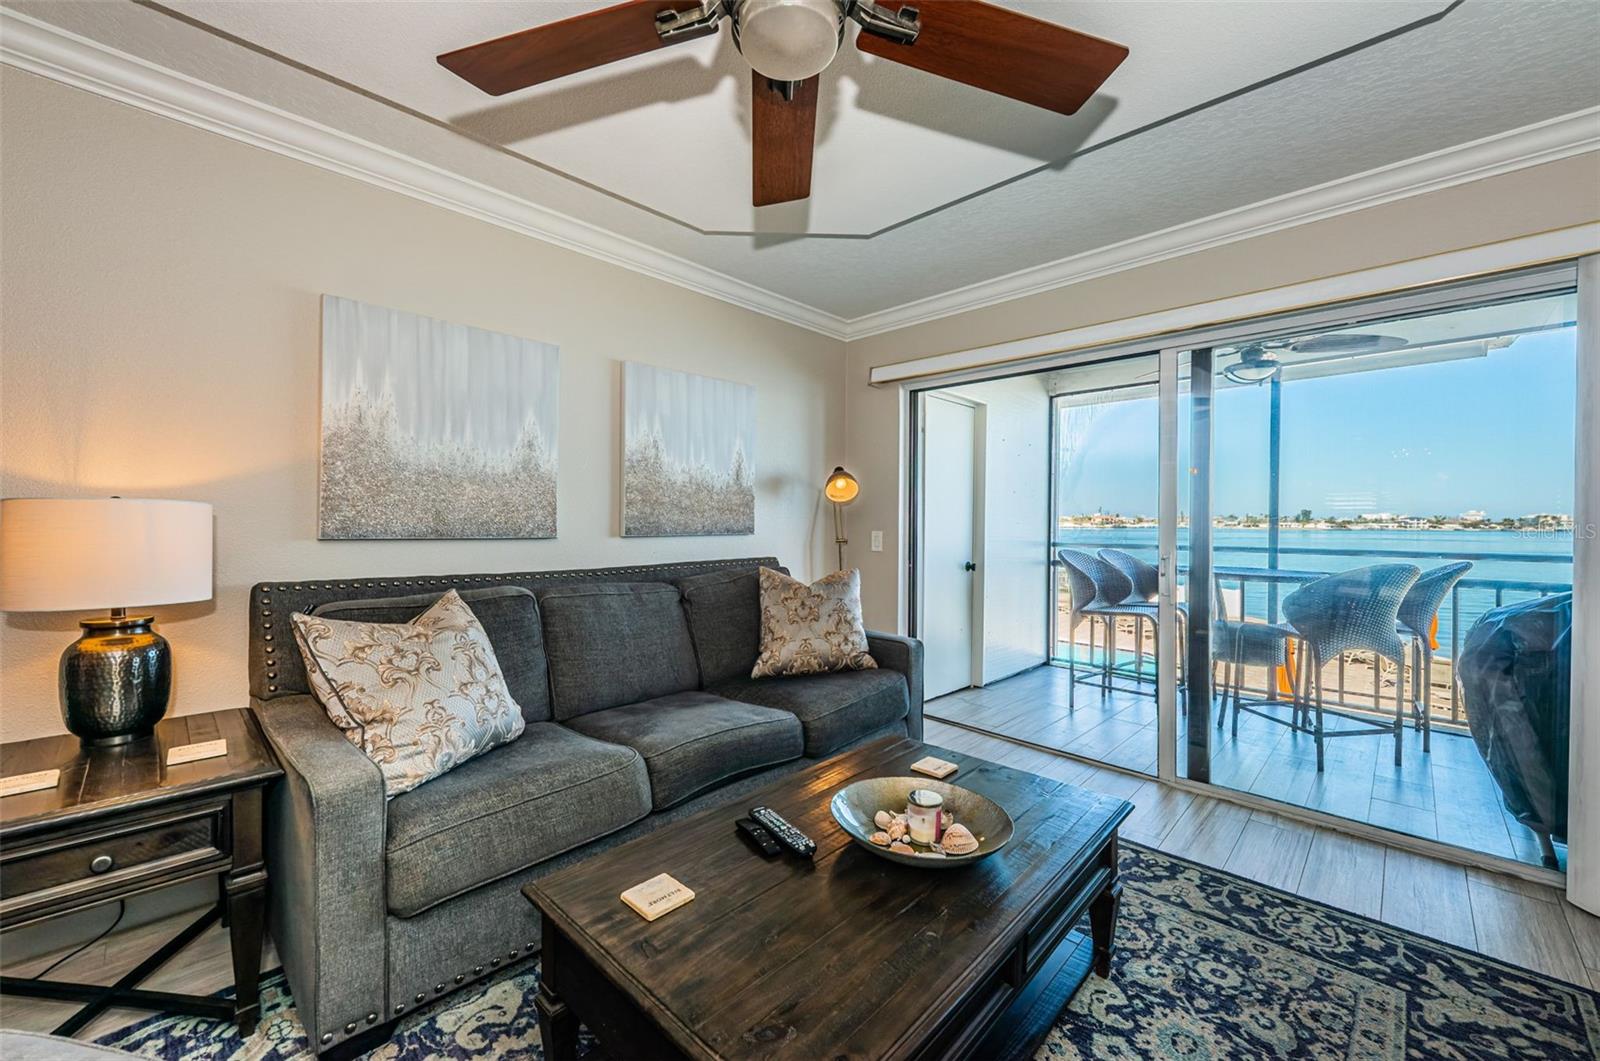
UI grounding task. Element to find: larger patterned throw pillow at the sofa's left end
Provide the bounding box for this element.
[290,589,523,799]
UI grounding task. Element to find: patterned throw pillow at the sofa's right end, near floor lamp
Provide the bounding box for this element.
[750,568,878,679]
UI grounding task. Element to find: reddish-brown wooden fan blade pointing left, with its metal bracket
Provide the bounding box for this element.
[438,0,717,96]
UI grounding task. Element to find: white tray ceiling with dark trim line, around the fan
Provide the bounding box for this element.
[0,0,1600,338]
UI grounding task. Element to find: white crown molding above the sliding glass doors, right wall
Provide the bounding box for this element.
[845,107,1600,339]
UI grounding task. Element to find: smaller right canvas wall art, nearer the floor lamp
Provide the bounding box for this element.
[622,362,755,538]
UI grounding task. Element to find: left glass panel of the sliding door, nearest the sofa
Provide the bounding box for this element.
[915,354,1162,775]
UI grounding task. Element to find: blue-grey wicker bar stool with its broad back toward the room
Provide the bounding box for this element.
[1283,563,1422,773]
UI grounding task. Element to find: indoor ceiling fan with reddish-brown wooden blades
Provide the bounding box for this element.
[438,0,1128,206]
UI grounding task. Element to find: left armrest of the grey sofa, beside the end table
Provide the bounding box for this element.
[251,696,390,1051]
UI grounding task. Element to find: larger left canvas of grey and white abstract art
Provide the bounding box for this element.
[317,294,560,538]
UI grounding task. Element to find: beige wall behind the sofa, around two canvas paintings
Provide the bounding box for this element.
[0,67,843,739]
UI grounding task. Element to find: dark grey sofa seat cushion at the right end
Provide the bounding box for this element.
[712,671,910,759]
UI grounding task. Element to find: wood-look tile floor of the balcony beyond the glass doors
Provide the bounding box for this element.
[926,666,1565,866]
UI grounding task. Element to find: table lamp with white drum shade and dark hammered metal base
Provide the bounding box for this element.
[0,498,211,744]
